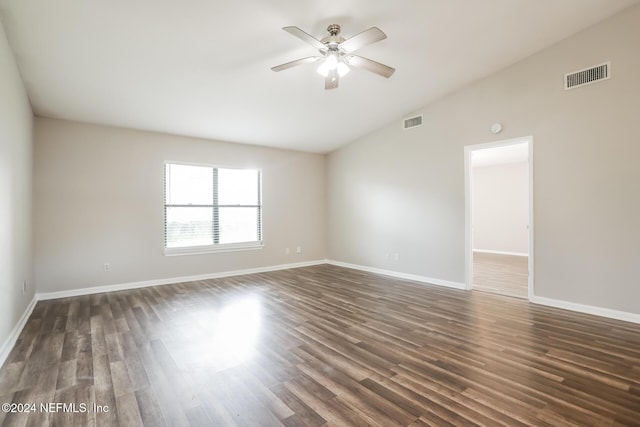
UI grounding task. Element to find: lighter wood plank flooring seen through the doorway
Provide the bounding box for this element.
[473,252,529,298]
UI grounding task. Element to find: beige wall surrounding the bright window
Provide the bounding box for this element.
[34,118,326,292]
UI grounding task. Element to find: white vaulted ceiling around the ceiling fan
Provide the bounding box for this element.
[0,0,639,152]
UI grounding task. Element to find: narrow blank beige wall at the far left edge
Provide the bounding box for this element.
[0,24,34,360]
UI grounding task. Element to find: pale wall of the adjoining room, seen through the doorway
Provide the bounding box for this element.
[472,162,529,255]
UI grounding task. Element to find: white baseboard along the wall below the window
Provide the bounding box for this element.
[36,260,327,301]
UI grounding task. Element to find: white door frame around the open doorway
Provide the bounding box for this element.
[464,136,534,301]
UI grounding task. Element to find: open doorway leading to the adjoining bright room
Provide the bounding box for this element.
[464,137,533,300]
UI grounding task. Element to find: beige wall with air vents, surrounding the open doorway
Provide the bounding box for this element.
[328,6,640,313]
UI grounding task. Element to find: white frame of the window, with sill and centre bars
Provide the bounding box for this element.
[162,161,264,256]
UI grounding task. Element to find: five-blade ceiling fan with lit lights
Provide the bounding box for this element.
[271,24,396,89]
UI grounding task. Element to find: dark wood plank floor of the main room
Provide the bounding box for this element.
[0,265,640,426]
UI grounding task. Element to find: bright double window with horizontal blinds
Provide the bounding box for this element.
[164,163,262,254]
